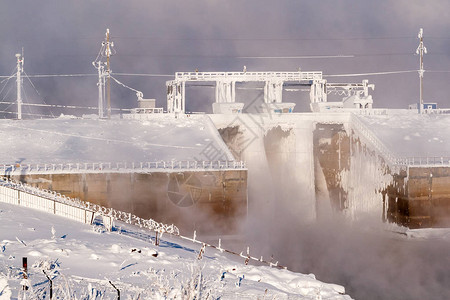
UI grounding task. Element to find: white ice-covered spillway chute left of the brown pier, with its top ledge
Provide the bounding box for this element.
[210,113,349,232]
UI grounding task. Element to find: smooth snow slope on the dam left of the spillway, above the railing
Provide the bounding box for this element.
[0,114,233,164]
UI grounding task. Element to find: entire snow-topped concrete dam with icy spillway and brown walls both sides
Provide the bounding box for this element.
[0,112,450,235]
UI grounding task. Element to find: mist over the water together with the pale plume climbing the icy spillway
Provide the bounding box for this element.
[229,119,450,300]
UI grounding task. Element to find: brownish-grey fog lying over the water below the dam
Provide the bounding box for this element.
[246,186,450,300]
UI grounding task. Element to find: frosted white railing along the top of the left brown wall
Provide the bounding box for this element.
[0,160,245,175]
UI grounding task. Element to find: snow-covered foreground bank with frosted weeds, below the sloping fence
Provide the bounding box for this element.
[0,203,351,299]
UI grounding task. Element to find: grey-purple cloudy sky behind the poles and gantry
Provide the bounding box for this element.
[0,0,450,115]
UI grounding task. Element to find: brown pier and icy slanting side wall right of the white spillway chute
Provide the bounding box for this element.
[314,123,396,221]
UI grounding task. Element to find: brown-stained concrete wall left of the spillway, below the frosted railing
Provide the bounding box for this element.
[11,170,247,235]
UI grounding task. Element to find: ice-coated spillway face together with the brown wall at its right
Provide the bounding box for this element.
[211,114,450,228]
